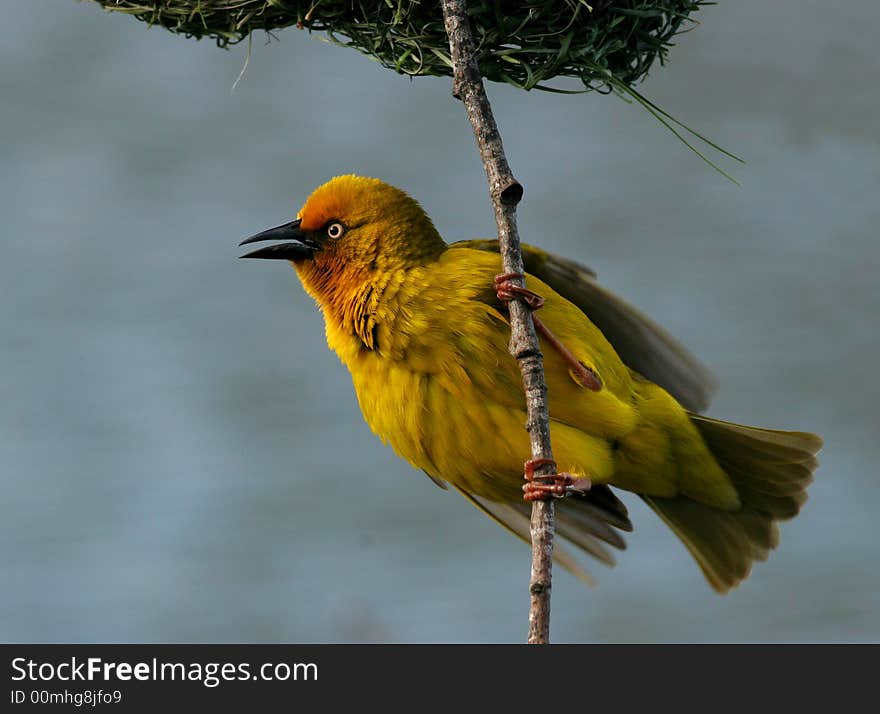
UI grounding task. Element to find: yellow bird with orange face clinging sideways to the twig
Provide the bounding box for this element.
[242,175,822,593]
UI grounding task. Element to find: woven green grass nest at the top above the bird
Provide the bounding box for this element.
[93,0,707,93]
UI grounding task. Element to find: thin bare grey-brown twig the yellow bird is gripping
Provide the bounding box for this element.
[441,0,555,644]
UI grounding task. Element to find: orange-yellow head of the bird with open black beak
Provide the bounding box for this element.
[241,175,446,303]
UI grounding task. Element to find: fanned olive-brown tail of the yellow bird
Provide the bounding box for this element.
[643,414,822,593]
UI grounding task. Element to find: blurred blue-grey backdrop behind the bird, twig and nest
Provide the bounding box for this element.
[0,0,880,642]
